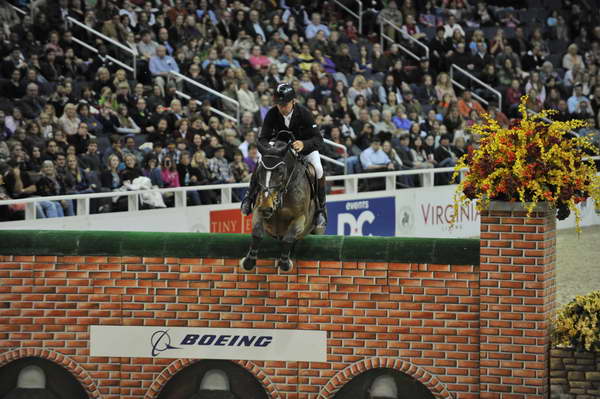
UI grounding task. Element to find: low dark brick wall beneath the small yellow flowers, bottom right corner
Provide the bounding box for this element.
[550,348,600,399]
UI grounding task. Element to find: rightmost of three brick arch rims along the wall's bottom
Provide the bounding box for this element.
[317,357,452,399]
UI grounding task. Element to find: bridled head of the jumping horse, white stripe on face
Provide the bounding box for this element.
[256,141,293,220]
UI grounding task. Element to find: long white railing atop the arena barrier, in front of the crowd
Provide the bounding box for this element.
[0,168,454,222]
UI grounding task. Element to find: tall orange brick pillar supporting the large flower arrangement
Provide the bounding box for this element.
[480,202,556,399]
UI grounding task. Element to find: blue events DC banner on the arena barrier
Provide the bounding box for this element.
[325,197,396,236]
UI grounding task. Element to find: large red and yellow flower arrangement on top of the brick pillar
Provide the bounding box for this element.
[454,97,600,230]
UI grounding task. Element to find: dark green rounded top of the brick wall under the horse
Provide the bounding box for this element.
[0,230,479,265]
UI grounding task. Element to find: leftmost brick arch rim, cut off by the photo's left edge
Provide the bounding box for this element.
[0,348,101,398]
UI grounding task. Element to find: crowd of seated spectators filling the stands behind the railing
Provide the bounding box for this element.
[0,0,600,220]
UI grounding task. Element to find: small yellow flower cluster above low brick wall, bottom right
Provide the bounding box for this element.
[552,291,600,352]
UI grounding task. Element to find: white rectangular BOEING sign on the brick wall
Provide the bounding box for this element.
[90,326,327,362]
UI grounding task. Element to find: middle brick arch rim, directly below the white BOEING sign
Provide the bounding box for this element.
[144,359,280,399]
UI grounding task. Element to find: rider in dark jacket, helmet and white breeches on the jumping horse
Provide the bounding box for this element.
[242,83,327,227]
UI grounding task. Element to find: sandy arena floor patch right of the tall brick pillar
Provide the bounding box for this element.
[557,226,600,305]
